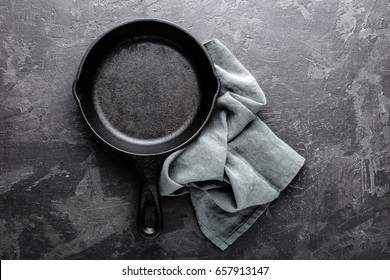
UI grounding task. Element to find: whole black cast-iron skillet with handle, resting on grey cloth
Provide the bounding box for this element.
[73,20,219,238]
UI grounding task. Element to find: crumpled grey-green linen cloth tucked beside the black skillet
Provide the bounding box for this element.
[160,39,305,250]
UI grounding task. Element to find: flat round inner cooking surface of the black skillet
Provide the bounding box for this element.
[93,37,200,144]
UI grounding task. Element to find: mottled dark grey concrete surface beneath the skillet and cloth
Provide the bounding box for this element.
[0,0,390,259]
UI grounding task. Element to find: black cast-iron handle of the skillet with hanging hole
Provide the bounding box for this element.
[137,156,164,239]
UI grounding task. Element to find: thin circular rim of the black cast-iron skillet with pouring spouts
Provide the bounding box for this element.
[72,19,220,157]
